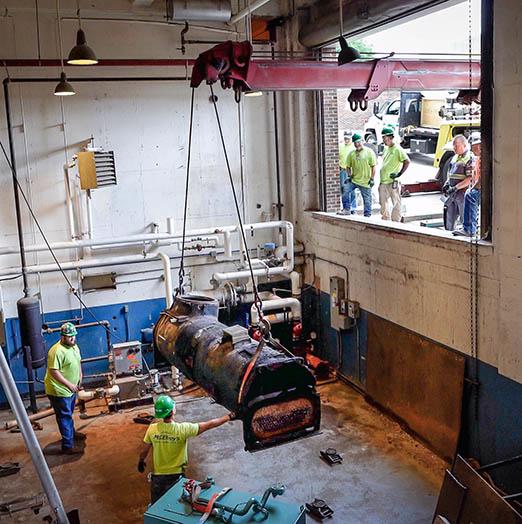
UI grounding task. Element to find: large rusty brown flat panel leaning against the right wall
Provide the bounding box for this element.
[366,314,465,460]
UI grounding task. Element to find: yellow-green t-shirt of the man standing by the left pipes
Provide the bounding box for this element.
[44,342,82,397]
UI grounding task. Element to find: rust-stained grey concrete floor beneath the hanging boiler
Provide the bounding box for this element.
[0,382,445,524]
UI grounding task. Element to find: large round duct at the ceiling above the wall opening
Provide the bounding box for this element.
[299,0,462,47]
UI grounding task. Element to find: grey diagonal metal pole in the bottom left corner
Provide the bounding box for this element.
[0,351,69,524]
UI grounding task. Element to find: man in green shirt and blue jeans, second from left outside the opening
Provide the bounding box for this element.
[343,133,377,217]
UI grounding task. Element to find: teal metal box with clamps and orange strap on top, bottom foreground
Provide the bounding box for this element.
[144,477,306,524]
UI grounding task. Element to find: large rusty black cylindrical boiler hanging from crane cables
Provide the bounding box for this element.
[154,295,321,451]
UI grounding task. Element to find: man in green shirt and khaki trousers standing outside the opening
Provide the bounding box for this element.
[379,127,410,222]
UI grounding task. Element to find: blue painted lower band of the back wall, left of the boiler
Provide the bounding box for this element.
[0,298,165,405]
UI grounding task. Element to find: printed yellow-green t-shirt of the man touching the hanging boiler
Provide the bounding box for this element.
[143,422,199,475]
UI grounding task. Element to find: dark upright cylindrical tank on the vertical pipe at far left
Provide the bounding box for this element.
[16,297,46,369]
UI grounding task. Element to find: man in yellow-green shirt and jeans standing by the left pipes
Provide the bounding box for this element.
[44,322,85,455]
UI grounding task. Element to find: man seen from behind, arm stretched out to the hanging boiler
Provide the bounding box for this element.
[138,395,235,504]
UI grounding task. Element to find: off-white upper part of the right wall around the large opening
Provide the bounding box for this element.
[276,0,522,382]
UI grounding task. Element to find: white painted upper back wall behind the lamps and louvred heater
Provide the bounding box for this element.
[0,0,275,317]
